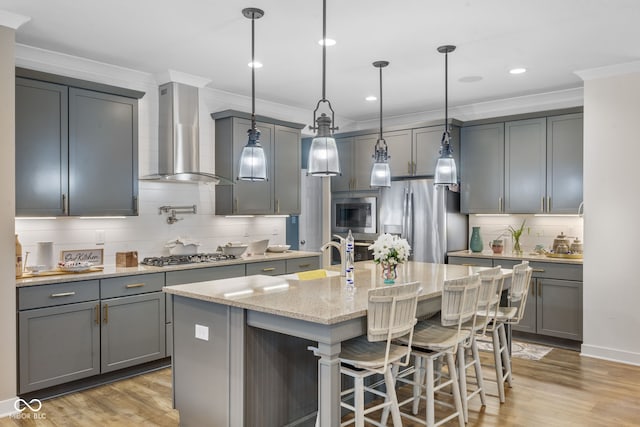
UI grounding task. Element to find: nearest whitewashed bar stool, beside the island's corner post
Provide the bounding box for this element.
[340,282,420,427]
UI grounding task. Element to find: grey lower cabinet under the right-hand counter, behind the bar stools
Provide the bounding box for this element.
[449,257,582,341]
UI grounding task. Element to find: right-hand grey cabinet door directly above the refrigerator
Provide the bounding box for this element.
[413,126,460,176]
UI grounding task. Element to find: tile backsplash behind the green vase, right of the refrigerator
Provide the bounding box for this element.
[469,215,588,253]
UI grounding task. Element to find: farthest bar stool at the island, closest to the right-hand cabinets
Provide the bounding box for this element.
[488,261,533,403]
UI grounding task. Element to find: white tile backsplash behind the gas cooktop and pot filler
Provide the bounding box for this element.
[16,181,286,265]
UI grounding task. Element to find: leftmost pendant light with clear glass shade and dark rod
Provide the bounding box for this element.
[238,7,267,181]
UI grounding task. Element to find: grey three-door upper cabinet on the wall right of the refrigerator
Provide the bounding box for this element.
[460,113,583,214]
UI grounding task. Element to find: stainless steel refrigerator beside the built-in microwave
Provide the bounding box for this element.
[378,179,468,263]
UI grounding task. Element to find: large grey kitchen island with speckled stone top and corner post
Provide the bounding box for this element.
[163,261,510,427]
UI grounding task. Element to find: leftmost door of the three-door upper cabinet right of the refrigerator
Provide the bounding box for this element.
[460,123,504,213]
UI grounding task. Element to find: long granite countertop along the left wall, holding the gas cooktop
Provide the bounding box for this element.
[16,251,321,287]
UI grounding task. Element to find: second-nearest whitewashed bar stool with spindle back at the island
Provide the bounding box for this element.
[390,274,480,427]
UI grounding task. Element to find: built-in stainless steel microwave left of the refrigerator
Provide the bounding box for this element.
[331,197,378,234]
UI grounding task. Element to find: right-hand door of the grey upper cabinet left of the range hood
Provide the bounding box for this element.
[69,88,138,215]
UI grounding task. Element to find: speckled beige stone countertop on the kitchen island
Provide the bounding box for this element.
[163,261,511,325]
